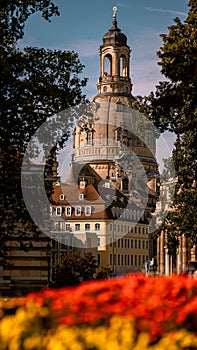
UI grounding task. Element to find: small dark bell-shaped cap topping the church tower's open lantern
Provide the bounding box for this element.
[102,18,127,46]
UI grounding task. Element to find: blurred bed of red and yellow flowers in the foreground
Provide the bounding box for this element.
[0,275,197,350]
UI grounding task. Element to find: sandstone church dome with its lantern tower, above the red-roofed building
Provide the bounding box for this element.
[73,8,157,195]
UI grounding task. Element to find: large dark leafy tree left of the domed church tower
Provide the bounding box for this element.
[0,0,87,264]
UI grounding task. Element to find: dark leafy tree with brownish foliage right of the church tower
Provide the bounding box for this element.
[145,0,197,246]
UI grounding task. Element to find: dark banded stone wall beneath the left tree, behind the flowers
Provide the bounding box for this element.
[0,234,50,294]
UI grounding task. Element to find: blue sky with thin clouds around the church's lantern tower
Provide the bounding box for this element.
[21,0,188,99]
